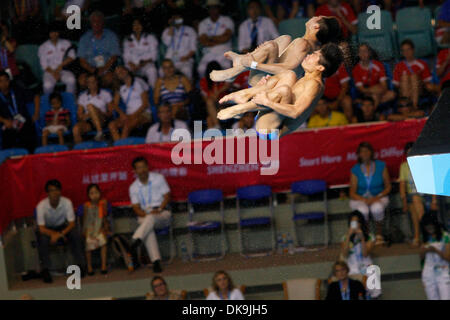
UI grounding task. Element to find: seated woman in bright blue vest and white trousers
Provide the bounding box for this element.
[350,142,391,245]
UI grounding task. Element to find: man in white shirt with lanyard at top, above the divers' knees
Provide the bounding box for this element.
[239,0,279,53]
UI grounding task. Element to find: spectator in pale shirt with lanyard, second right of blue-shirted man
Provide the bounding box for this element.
[161,13,197,81]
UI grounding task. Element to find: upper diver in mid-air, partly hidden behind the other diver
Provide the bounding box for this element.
[210,16,341,86]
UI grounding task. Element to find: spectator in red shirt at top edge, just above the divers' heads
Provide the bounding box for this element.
[315,0,358,38]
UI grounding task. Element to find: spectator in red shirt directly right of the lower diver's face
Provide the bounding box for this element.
[323,64,353,123]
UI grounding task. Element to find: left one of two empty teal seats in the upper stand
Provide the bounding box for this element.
[357,10,397,60]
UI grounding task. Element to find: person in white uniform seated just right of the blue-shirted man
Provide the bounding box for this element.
[123,18,159,88]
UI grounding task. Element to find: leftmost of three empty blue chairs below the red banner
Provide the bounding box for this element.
[188,189,225,261]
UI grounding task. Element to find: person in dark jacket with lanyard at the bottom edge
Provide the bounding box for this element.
[325,261,366,300]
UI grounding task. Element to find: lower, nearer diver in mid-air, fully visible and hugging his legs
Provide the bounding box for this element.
[217,43,343,140]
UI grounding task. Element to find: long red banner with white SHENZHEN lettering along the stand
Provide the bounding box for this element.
[0,119,425,232]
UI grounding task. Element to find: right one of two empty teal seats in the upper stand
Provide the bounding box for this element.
[396,7,436,58]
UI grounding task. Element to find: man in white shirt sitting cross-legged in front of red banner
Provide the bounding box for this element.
[130,157,171,273]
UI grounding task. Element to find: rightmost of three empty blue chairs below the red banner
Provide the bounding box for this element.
[291,180,329,248]
